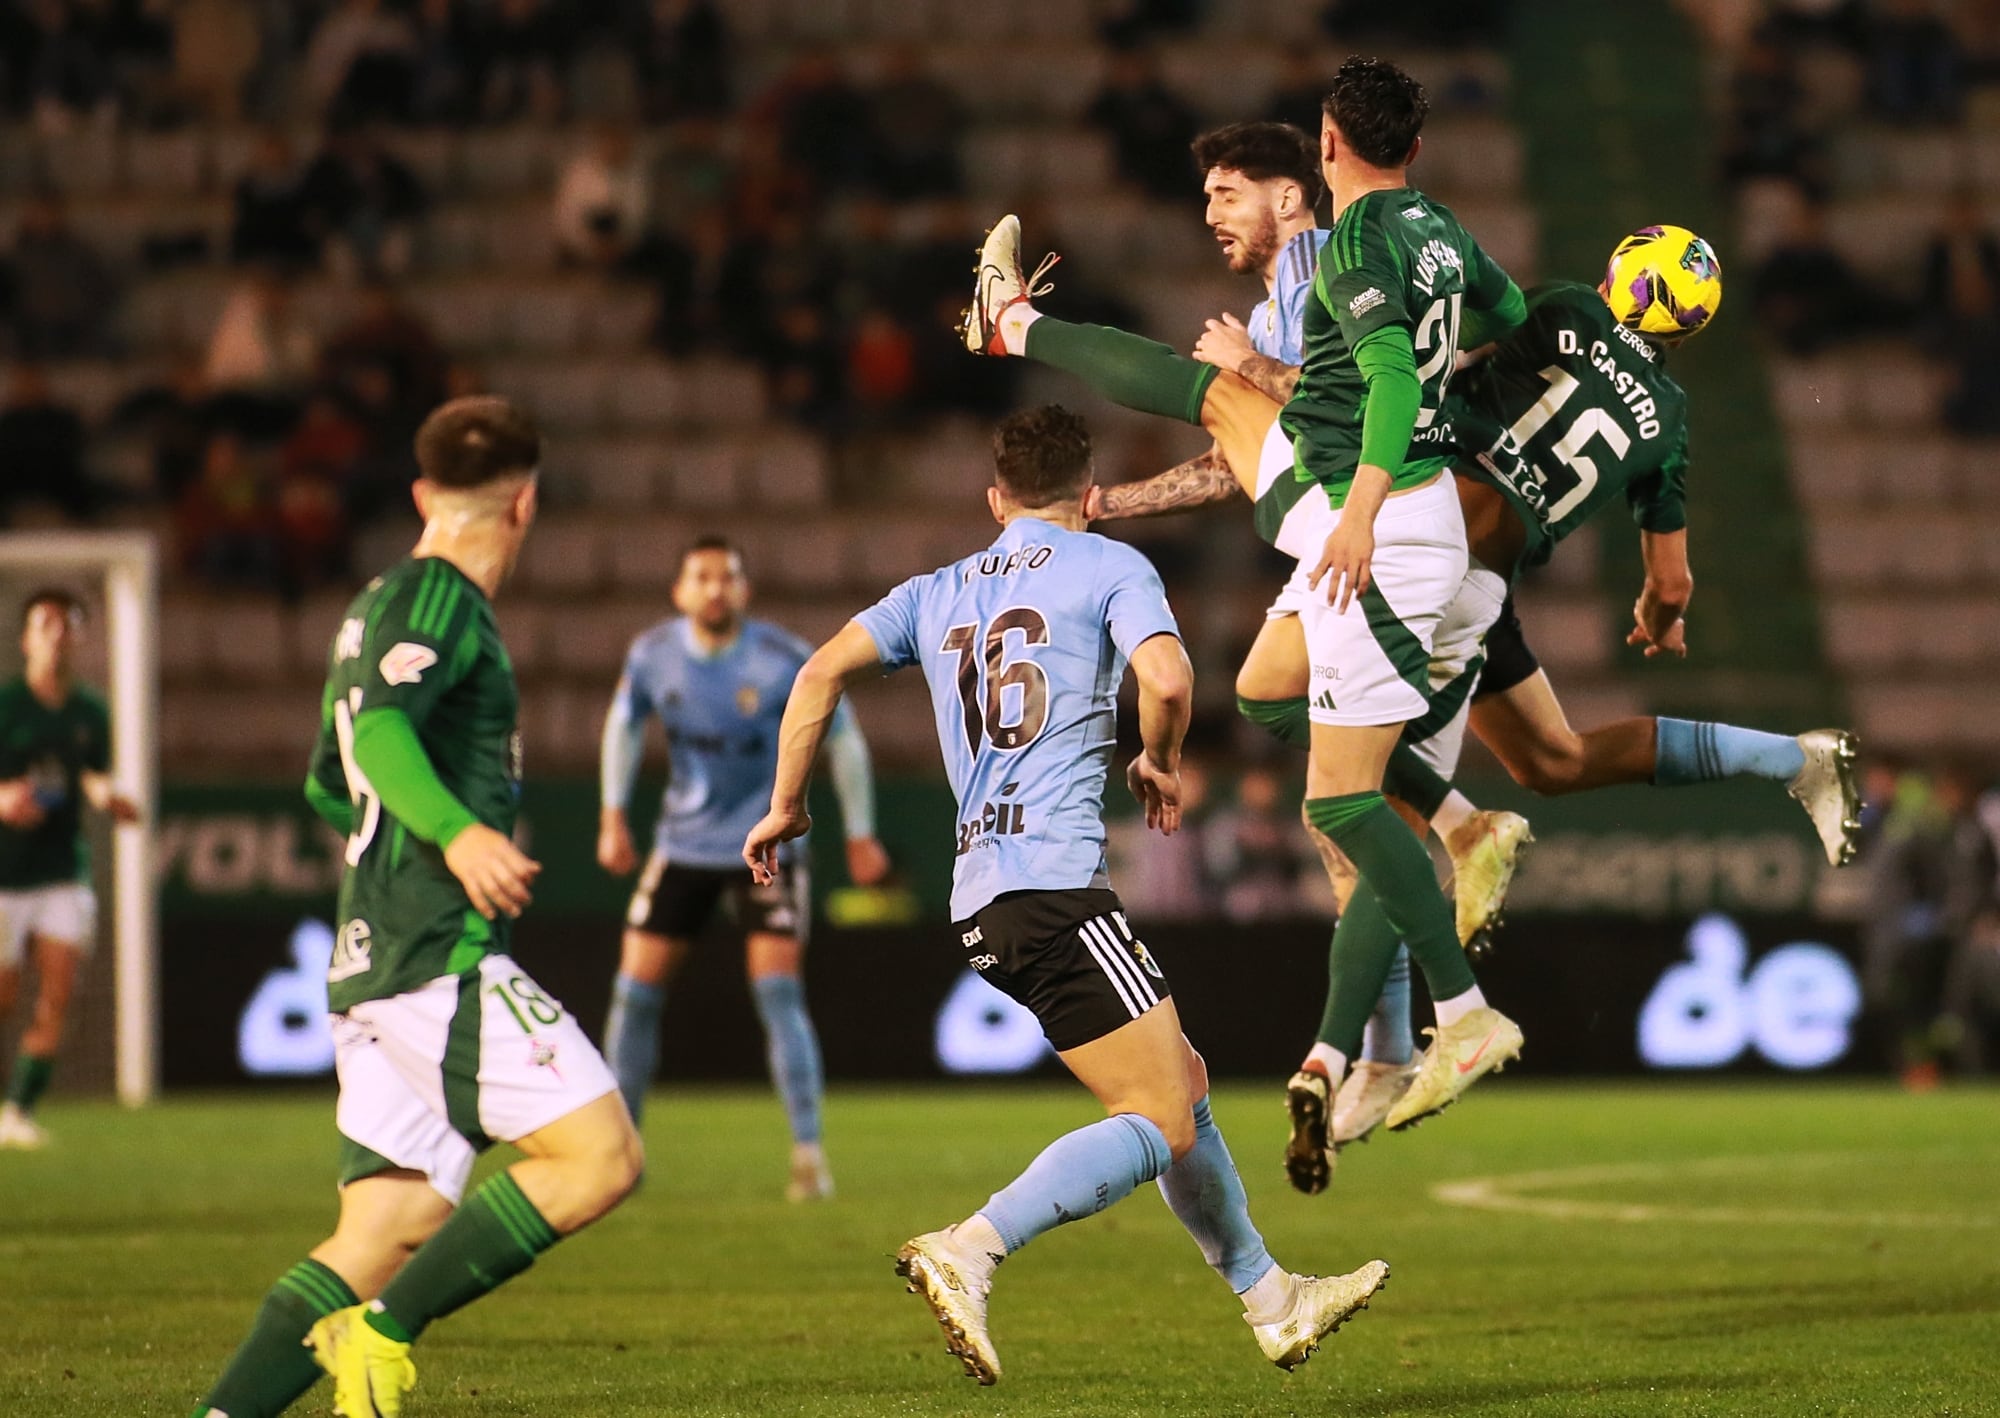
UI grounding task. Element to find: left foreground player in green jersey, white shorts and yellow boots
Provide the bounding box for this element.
[194,398,642,1418]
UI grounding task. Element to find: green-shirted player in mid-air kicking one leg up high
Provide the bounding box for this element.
[966,58,1522,1126]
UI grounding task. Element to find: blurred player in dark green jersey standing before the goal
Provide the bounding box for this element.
[0,590,138,1152]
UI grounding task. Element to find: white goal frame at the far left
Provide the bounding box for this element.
[0,532,160,1108]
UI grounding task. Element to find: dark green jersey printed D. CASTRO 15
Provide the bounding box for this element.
[1448,280,1688,566]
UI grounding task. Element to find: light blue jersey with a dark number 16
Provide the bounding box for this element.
[854,518,1180,920]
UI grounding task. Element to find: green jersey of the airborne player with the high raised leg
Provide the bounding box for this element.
[1256,188,1514,542]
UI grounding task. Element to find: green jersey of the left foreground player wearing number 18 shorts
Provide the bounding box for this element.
[312,558,520,1010]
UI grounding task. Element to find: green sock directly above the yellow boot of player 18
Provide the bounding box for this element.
[368,1172,560,1344]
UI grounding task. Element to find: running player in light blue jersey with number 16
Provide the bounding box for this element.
[744,406,1388,1384]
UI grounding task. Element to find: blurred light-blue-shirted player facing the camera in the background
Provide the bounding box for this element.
[598,536,888,1202]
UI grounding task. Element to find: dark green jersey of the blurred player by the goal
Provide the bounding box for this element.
[0,678,112,892]
